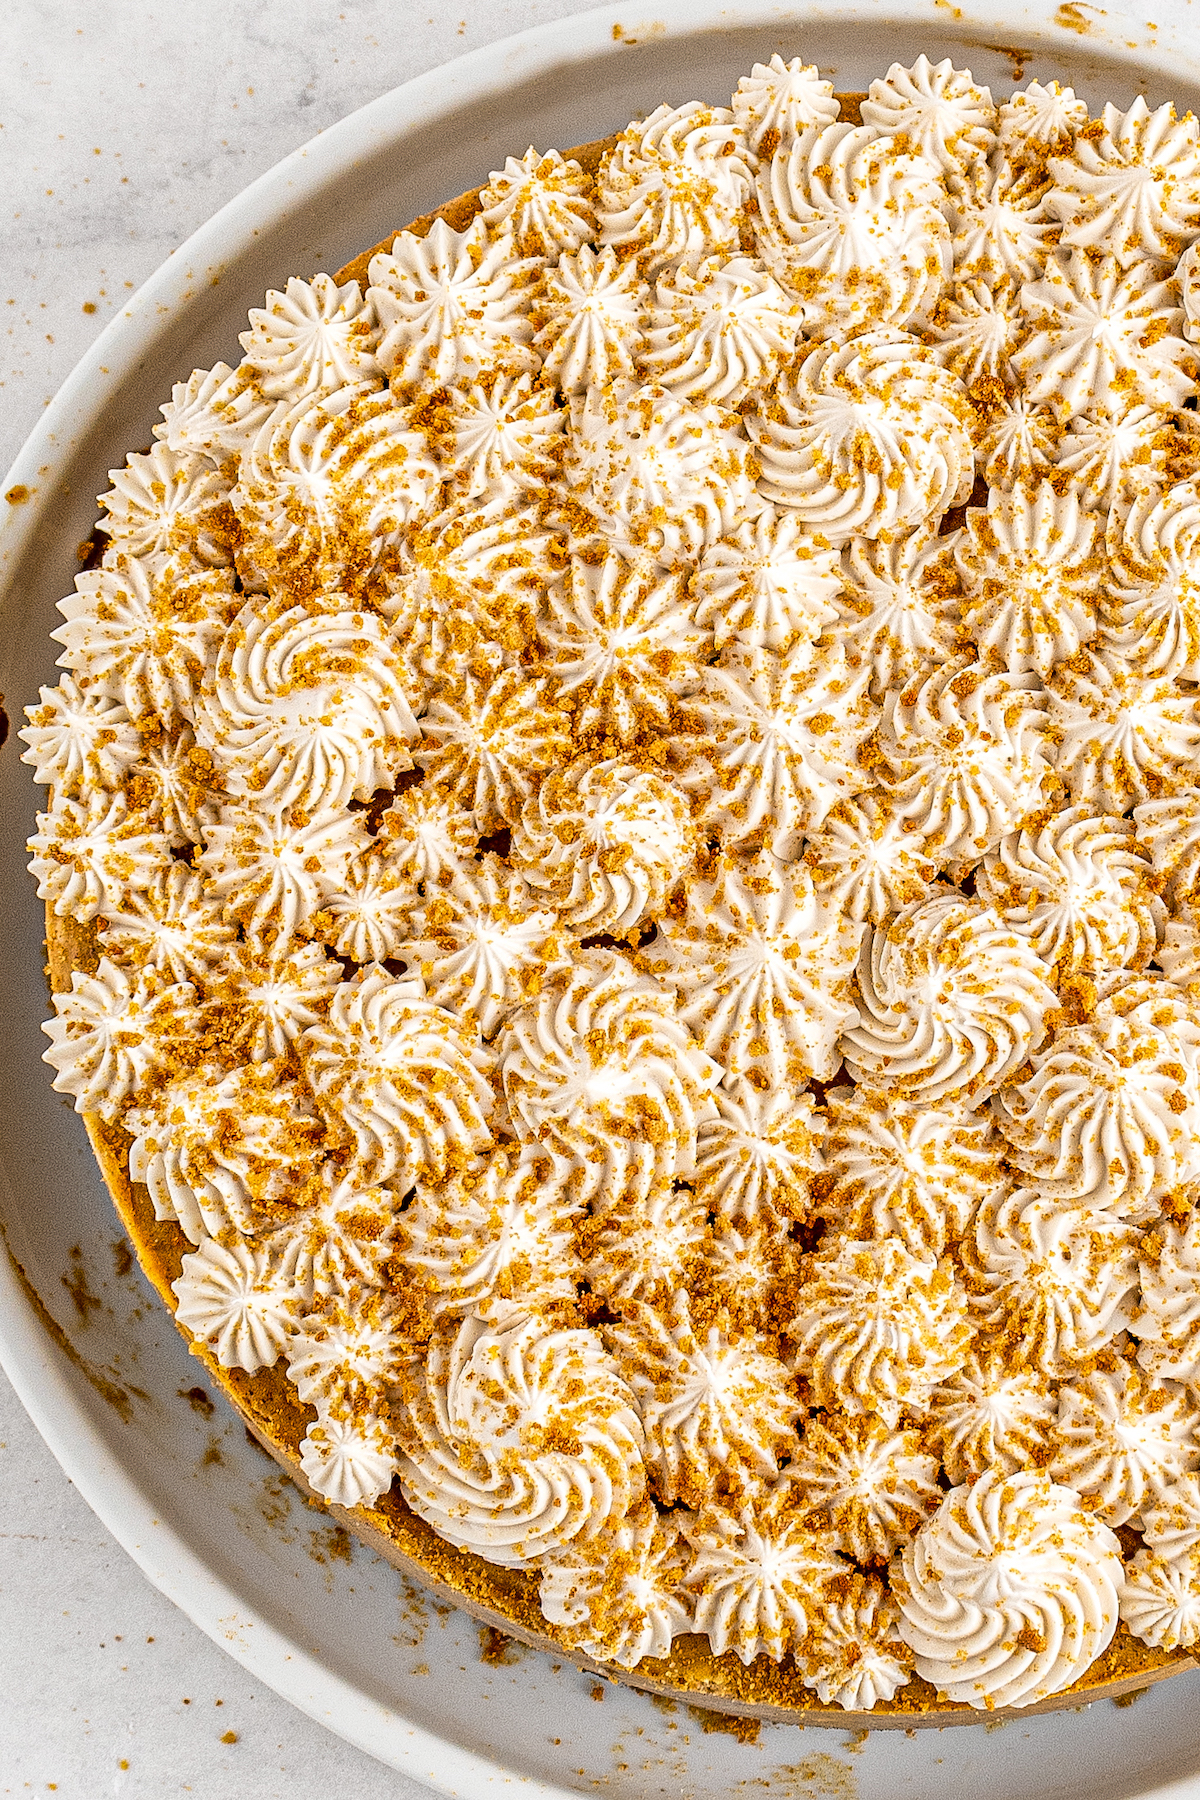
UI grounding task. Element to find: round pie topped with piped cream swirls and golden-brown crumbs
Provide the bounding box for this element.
[22,56,1200,1726]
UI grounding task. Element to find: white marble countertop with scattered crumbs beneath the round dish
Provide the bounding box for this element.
[0,0,590,1800]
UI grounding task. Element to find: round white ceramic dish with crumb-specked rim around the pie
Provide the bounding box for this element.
[0,0,1200,1800]
